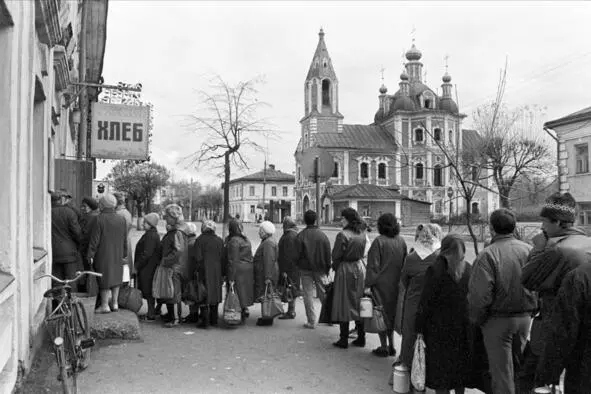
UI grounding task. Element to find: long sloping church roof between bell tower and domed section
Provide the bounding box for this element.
[316,124,397,152]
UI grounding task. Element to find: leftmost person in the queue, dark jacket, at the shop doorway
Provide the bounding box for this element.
[51,193,82,291]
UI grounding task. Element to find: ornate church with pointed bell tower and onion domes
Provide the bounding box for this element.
[295,30,498,222]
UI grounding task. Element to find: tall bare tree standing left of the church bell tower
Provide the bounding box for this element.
[186,76,270,223]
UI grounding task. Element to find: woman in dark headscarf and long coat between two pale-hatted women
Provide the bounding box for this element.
[225,219,254,321]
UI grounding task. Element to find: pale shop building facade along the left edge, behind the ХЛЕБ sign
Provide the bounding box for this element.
[0,0,107,393]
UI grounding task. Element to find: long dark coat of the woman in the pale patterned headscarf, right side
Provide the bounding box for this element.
[400,250,439,368]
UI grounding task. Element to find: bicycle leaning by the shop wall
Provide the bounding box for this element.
[39,271,102,394]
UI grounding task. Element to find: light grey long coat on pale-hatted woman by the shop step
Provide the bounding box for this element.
[87,208,127,290]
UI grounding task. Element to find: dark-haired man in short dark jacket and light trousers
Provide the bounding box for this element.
[297,211,331,328]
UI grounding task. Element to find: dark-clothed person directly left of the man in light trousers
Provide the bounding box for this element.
[277,216,301,319]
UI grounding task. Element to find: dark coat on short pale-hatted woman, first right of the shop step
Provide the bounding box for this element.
[133,227,162,298]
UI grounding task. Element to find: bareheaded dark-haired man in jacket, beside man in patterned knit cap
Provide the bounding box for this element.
[468,208,537,394]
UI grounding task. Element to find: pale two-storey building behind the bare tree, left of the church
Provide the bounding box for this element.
[230,164,295,222]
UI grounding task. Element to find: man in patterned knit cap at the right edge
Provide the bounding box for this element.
[522,193,591,389]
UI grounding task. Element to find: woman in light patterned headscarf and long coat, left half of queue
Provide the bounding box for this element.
[160,204,190,328]
